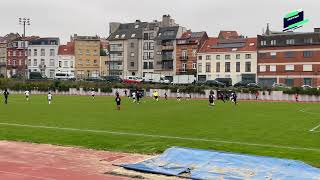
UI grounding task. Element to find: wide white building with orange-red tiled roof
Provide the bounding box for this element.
[197,31,257,84]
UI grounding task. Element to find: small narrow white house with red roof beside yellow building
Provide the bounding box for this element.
[56,42,76,76]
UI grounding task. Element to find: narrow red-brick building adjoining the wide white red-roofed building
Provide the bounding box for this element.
[176,30,208,75]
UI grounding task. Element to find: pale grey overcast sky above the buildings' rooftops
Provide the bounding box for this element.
[0,0,320,43]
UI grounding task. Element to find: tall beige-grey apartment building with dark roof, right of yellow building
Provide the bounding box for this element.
[108,20,148,77]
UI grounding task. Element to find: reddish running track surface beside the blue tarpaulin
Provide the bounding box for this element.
[0,141,147,180]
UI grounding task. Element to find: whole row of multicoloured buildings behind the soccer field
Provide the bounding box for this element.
[0,15,320,87]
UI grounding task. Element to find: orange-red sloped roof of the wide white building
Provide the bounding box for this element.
[199,37,257,53]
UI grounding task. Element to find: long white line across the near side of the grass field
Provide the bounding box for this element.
[0,123,320,152]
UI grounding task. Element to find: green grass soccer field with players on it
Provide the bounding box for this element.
[0,95,320,167]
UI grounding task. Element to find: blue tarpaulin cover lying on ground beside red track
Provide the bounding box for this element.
[121,147,320,180]
